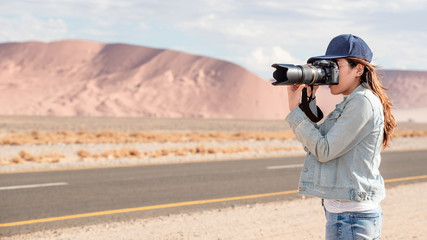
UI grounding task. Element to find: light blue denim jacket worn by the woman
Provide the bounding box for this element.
[286,85,385,202]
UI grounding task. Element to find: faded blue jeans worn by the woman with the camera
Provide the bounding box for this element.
[325,206,383,240]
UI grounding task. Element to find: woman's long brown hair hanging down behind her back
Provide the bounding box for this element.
[346,57,396,149]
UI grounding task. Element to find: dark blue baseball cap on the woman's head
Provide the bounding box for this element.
[307,34,373,63]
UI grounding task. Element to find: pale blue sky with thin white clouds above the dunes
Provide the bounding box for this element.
[0,0,427,79]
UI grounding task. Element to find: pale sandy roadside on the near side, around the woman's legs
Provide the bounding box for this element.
[6,182,427,240]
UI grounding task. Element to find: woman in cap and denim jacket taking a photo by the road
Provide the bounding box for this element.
[286,34,396,239]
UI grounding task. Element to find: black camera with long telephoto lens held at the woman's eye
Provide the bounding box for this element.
[271,60,339,86]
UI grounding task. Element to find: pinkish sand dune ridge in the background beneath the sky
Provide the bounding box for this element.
[0,40,427,119]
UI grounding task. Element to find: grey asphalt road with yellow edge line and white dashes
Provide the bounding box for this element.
[0,151,427,236]
